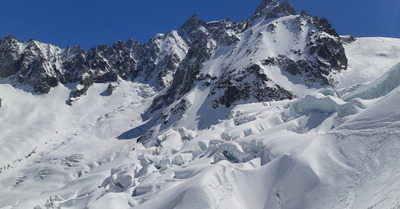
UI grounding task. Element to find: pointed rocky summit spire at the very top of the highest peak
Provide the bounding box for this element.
[252,0,297,19]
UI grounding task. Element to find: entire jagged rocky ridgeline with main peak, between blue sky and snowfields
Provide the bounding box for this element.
[0,0,347,123]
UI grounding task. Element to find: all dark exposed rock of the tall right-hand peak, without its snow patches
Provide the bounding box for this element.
[150,0,347,112]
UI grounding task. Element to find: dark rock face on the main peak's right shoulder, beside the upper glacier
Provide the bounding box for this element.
[262,13,348,86]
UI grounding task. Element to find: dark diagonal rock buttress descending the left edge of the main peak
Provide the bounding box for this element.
[150,16,246,112]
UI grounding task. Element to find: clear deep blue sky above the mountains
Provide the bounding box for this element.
[0,0,400,49]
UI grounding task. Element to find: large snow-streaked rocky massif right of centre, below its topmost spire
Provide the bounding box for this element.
[139,9,347,143]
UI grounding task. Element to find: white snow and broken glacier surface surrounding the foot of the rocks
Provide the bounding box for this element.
[0,36,400,209]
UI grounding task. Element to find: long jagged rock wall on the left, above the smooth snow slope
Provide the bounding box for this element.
[0,31,187,100]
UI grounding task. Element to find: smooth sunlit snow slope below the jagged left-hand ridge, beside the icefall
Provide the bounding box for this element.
[0,81,154,208]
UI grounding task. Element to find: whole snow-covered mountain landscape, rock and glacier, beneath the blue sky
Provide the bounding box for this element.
[0,0,400,209]
